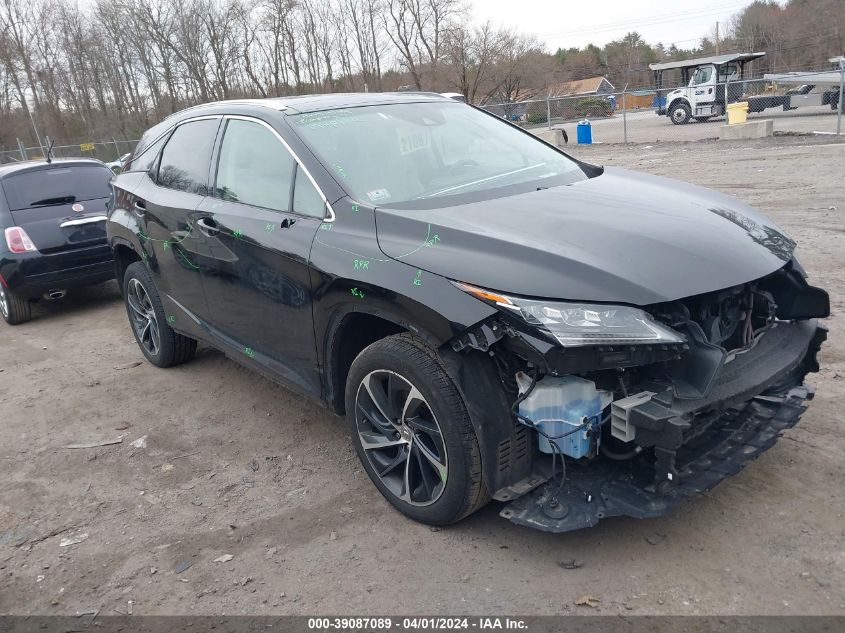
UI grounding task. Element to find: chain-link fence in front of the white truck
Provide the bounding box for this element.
[482,70,845,143]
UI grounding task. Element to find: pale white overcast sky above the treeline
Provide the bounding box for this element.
[472,0,764,51]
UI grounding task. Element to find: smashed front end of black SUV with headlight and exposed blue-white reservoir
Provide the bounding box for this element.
[452,260,829,532]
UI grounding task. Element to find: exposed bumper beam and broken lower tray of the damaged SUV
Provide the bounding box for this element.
[501,320,827,532]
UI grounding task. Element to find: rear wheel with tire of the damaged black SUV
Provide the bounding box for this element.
[123,262,197,367]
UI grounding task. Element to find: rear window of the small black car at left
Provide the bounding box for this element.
[2,165,114,211]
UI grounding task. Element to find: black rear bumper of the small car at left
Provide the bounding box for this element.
[0,244,115,299]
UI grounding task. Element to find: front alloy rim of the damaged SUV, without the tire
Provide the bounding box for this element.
[355,370,449,506]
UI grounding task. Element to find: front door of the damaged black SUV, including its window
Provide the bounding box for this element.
[197,116,325,393]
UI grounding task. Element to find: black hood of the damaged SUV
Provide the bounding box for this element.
[376,168,795,305]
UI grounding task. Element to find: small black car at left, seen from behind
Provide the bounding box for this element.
[0,158,114,325]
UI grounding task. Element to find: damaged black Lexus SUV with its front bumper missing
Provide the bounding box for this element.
[107,93,829,531]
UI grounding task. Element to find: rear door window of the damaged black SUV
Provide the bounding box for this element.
[158,119,219,196]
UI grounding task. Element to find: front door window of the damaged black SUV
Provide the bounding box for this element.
[215,119,296,211]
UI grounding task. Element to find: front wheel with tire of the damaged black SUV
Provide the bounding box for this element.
[346,334,489,525]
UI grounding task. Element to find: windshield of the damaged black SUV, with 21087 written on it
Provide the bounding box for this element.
[291,101,586,206]
